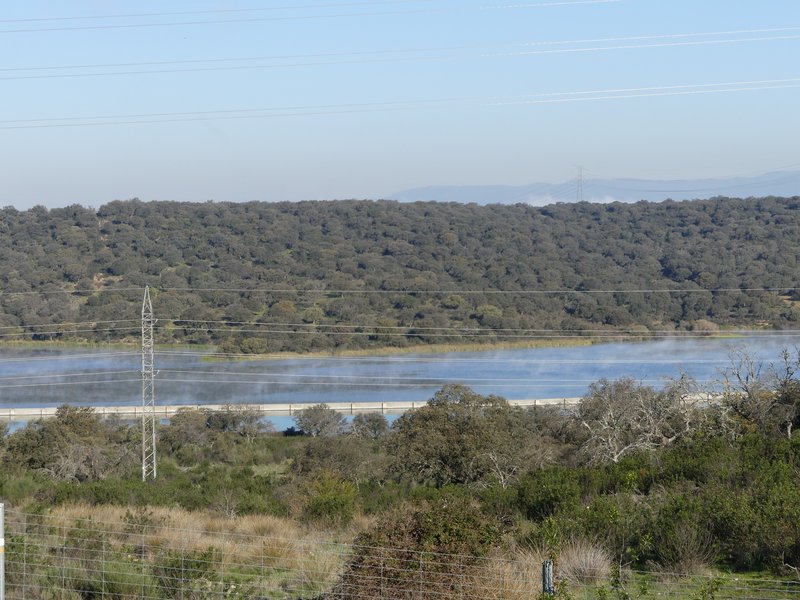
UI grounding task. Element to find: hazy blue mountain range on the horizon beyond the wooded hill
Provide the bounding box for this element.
[386,171,800,206]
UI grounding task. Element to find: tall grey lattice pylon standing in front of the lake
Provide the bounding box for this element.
[142,287,156,481]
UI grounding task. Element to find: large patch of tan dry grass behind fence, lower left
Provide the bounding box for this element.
[31,504,350,593]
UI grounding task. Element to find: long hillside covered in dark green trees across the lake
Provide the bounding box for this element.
[0,197,800,352]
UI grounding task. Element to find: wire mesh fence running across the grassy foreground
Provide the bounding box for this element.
[5,510,800,600]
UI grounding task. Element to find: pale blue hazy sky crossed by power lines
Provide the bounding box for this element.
[0,0,800,208]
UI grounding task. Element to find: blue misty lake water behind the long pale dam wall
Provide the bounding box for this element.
[0,334,800,407]
